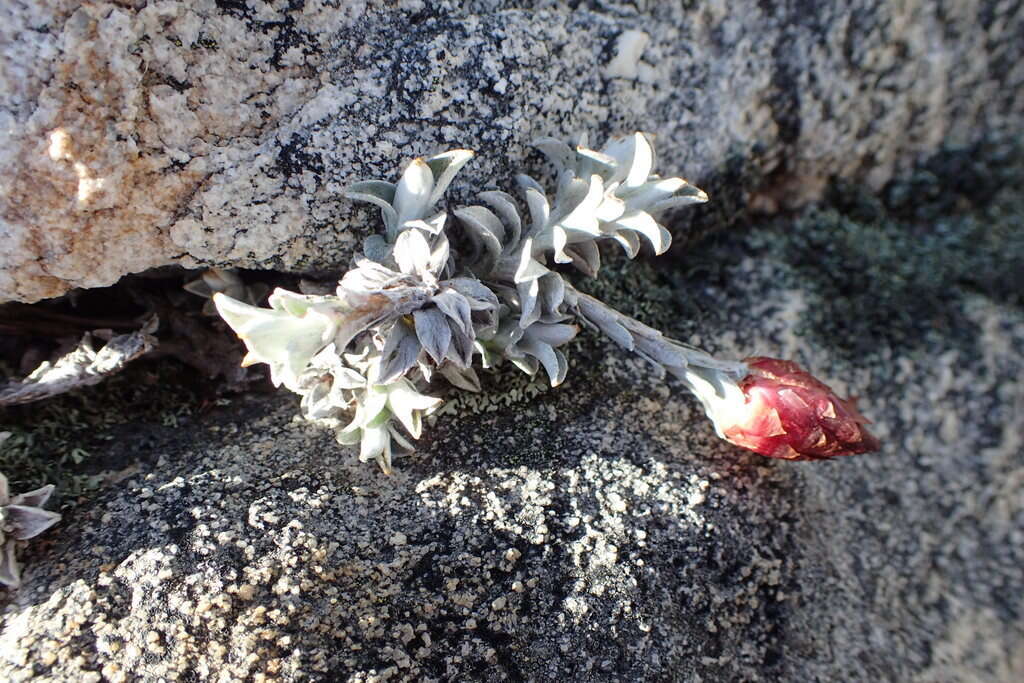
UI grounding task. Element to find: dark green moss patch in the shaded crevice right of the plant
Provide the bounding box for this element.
[673,140,1024,357]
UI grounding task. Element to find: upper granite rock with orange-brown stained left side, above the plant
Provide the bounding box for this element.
[0,0,1024,301]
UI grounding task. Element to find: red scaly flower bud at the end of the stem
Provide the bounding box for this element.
[722,357,880,460]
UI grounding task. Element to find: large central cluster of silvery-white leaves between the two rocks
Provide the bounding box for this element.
[214,133,711,472]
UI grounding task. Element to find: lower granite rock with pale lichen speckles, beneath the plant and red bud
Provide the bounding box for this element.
[0,174,1024,683]
